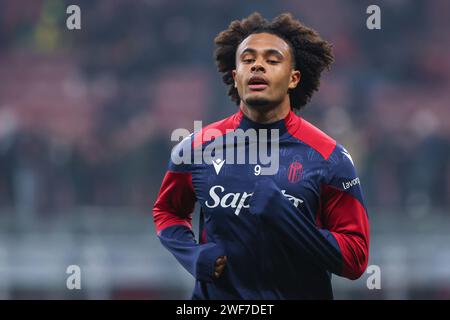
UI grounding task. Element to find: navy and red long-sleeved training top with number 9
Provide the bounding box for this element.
[153,110,369,299]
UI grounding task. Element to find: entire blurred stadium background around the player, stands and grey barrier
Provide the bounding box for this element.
[0,0,450,299]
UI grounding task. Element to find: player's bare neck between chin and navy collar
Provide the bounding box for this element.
[239,98,291,124]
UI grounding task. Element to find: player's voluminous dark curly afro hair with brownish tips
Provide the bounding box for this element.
[214,12,334,110]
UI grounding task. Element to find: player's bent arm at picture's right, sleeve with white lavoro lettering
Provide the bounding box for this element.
[250,146,369,279]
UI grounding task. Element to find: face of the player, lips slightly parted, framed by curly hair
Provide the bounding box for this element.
[233,33,300,107]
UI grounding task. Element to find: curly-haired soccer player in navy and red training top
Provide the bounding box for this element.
[153,13,369,299]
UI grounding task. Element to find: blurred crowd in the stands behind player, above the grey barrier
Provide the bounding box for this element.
[0,0,450,216]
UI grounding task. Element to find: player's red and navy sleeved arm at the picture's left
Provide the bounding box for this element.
[153,140,225,281]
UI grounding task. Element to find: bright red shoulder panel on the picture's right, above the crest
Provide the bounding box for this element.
[287,112,338,160]
